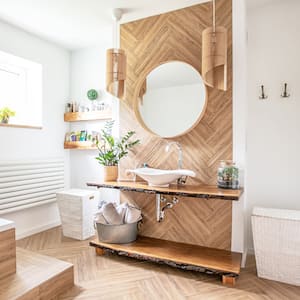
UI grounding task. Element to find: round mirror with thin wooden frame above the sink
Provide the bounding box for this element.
[135,61,207,138]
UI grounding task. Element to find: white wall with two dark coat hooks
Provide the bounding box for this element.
[246,0,300,247]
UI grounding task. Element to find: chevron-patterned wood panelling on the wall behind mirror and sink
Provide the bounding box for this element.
[120,0,232,249]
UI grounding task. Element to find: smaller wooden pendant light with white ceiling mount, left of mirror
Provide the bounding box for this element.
[106,8,126,98]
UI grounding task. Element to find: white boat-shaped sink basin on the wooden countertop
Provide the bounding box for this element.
[126,168,196,187]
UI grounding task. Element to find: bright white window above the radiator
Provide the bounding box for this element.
[0,51,42,126]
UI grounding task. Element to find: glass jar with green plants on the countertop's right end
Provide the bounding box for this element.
[218,160,239,189]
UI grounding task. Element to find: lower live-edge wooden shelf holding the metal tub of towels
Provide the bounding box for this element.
[90,236,242,284]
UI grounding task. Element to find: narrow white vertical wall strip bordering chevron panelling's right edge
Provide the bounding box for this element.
[231,0,247,258]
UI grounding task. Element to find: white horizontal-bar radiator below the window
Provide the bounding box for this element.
[0,159,64,215]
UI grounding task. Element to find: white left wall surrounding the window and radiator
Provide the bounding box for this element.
[0,22,70,237]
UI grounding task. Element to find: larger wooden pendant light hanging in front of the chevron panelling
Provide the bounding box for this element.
[202,0,227,91]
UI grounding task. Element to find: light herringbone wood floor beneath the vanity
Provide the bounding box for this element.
[17,227,300,300]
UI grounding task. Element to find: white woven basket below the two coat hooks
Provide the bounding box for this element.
[251,207,300,286]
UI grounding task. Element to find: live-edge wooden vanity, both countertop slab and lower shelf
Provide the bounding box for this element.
[87,181,243,284]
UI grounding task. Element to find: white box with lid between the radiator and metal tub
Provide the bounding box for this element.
[56,189,99,240]
